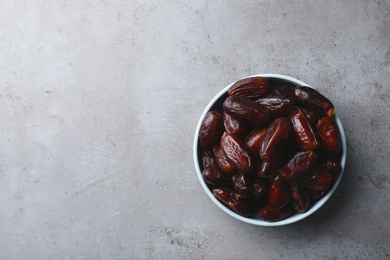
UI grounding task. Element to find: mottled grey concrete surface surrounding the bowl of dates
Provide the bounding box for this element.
[0,0,390,259]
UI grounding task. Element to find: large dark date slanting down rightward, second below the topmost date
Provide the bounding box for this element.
[223,96,270,125]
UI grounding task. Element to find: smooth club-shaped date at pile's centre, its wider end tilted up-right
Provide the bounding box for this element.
[259,117,291,161]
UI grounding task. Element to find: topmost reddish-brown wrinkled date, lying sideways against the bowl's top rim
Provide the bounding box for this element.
[228,77,270,97]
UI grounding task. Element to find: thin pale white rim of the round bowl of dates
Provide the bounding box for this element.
[193,73,347,226]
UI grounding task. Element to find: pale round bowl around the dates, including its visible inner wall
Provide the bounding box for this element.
[193,74,347,226]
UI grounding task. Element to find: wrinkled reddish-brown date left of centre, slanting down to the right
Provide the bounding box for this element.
[221,132,252,173]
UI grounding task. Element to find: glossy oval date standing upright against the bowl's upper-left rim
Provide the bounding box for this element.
[199,111,224,149]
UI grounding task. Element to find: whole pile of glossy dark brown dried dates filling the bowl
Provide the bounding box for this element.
[199,77,342,221]
